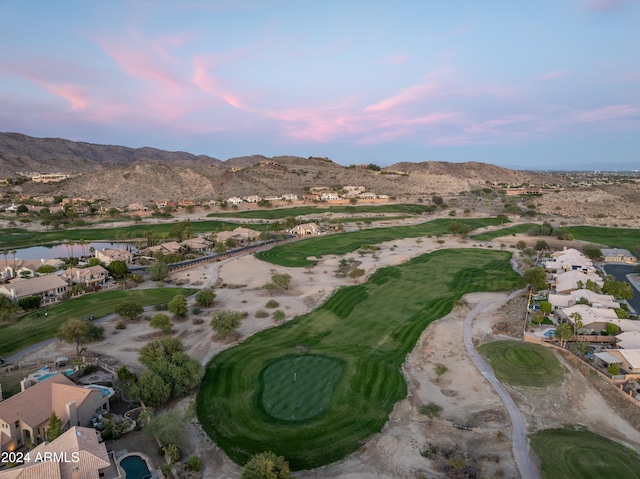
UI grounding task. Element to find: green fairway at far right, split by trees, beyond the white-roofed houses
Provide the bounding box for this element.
[471,223,640,252]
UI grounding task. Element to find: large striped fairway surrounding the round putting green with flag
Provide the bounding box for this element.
[196,249,518,470]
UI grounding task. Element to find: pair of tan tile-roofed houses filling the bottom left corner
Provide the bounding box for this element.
[0,373,115,479]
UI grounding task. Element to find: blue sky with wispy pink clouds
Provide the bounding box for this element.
[0,0,640,170]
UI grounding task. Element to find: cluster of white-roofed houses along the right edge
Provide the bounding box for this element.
[544,248,640,374]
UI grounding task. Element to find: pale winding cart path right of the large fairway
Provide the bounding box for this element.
[464,291,540,479]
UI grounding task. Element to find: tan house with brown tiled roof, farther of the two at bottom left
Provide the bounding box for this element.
[0,374,109,451]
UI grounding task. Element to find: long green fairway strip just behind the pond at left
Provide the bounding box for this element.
[0,220,266,250]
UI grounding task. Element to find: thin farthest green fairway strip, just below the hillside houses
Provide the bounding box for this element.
[207,204,433,220]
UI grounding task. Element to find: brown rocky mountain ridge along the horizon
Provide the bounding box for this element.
[0,133,549,206]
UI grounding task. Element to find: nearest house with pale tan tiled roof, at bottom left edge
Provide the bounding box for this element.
[0,426,111,479]
